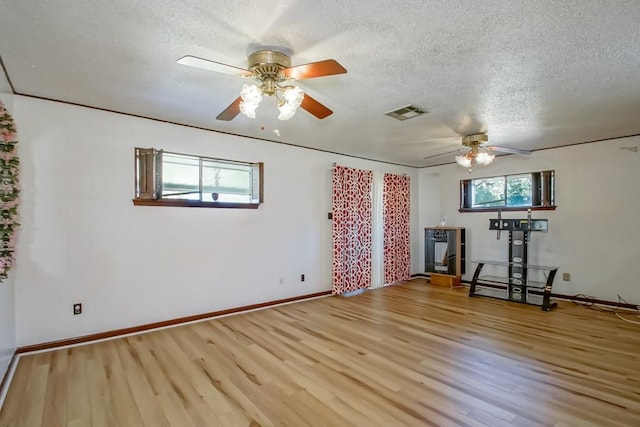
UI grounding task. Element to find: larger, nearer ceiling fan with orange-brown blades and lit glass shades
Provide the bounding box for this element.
[177,50,347,121]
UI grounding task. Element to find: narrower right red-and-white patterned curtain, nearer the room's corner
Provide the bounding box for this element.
[382,174,411,284]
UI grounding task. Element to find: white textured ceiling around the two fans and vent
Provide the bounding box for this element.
[0,0,640,166]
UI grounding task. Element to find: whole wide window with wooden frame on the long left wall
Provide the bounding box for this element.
[133,148,263,209]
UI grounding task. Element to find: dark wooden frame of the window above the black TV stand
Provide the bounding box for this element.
[458,170,557,212]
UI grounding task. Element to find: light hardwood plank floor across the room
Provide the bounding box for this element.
[0,279,640,427]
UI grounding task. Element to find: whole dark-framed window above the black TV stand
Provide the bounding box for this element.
[460,171,555,212]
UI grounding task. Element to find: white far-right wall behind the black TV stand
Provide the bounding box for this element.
[420,137,640,304]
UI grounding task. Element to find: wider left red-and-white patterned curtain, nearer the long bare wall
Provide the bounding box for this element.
[332,166,373,294]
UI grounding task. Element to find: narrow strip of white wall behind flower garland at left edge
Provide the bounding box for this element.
[0,93,20,380]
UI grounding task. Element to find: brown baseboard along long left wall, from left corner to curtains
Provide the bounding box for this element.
[14,291,331,357]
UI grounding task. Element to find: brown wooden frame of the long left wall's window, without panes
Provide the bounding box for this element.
[133,147,264,209]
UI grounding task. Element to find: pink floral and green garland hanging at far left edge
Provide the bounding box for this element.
[0,101,20,282]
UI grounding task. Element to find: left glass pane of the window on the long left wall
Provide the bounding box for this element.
[162,153,200,200]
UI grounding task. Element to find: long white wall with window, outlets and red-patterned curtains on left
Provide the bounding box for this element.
[14,96,420,346]
